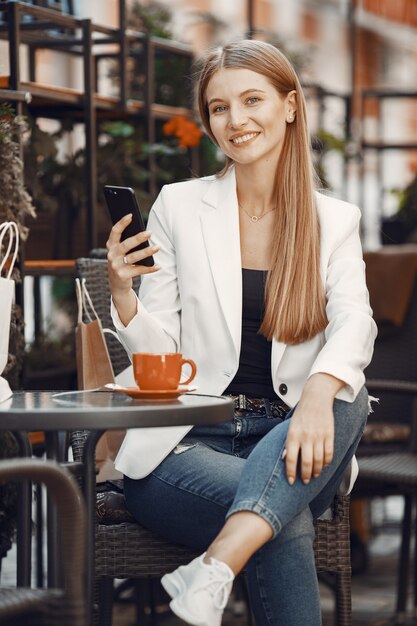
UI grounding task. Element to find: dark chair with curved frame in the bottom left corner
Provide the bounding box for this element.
[0,459,86,626]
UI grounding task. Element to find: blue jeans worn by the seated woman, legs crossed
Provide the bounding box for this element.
[124,388,368,626]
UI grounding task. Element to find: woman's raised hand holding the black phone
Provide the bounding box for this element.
[106,214,160,325]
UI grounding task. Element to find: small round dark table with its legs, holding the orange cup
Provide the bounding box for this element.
[0,391,234,611]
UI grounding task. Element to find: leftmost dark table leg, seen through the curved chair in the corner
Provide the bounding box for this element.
[13,431,32,587]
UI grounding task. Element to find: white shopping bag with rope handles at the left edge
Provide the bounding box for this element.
[0,222,19,402]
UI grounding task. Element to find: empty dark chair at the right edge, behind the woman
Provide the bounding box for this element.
[354,252,417,624]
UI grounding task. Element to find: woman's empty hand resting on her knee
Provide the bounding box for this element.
[285,373,344,485]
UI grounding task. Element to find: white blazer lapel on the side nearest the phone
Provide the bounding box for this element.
[201,168,242,358]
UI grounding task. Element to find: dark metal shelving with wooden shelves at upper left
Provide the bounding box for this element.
[0,0,198,253]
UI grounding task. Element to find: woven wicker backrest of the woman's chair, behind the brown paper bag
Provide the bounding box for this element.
[76,258,140,375]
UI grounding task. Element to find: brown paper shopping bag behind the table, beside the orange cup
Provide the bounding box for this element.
[75,278,126,482]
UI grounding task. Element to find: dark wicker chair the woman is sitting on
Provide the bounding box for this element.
[72,258,352,626]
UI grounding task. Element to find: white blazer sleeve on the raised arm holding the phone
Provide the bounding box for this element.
[111,189,181,355]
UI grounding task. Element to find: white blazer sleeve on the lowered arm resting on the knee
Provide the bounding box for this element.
[309,205,377,401]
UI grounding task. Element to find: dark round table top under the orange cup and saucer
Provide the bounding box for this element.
[0,391,234,431]
